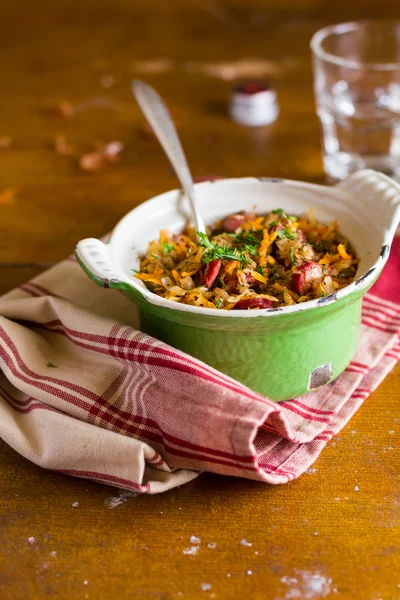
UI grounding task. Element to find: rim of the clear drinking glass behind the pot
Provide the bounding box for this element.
[310,19,400,71]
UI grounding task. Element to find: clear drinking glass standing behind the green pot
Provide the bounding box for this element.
[311,20,400,179]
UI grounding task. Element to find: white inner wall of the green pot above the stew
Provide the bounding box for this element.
[109,178,383,286]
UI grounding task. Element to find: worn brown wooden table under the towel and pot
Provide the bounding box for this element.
[0,0,400,600]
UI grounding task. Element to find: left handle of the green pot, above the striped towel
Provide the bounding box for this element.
[75,238,131,289]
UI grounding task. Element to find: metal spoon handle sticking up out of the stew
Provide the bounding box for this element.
[132,79,206,233]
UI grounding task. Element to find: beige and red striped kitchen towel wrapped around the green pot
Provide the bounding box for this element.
[0,239,400,493]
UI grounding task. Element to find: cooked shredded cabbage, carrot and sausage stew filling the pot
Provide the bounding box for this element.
[135,208,359,310]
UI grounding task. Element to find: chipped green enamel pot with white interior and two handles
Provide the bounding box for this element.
[76,170,400,401]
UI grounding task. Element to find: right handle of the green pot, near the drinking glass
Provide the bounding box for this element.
[336,169,400,243]
